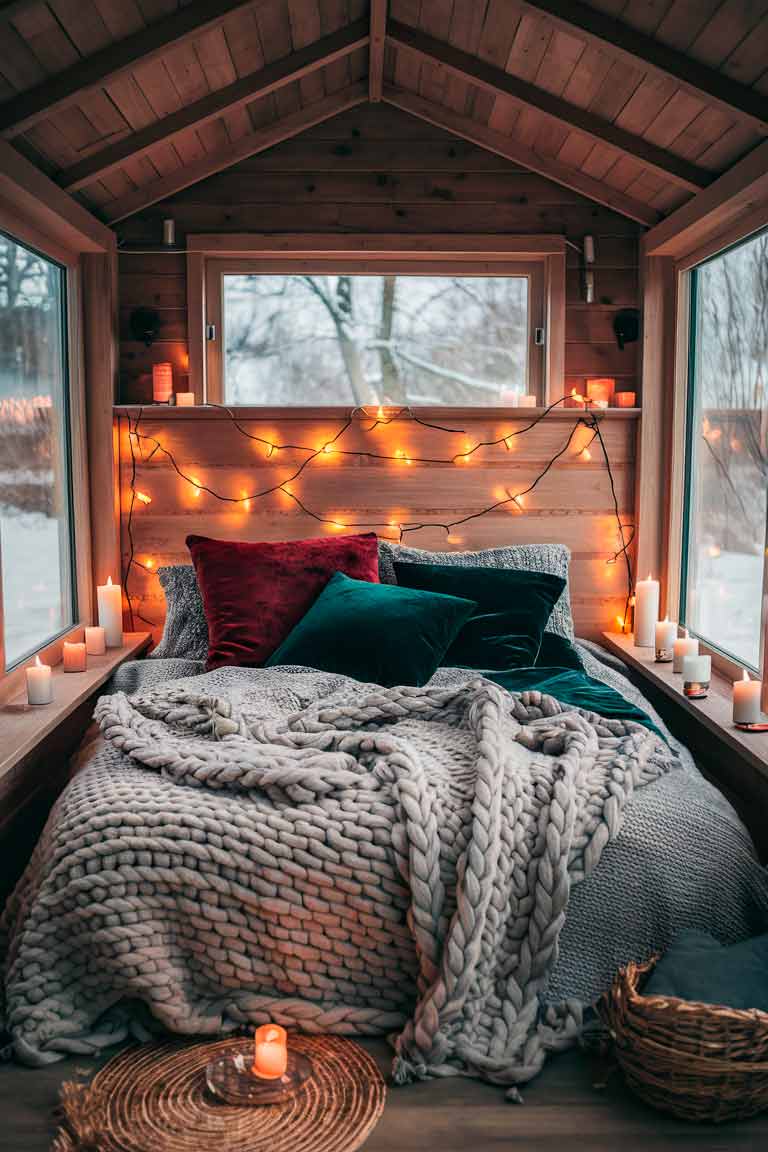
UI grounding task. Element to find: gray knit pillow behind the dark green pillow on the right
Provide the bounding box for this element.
[379,540,573,641]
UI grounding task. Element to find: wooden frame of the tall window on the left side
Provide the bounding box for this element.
[0,223,92,703]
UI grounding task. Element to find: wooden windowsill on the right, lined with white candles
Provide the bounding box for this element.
[602,632,768,776]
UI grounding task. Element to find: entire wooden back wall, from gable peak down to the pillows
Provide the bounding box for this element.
[113,105,641,635]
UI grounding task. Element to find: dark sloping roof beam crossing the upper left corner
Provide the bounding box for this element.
[0,0,261,139]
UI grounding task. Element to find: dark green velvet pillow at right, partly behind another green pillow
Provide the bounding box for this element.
[394,560,565,670]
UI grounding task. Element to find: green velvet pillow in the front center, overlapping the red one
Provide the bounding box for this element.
[267,573,477,687]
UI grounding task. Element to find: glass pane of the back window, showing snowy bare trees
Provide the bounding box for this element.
[223,274,530,407]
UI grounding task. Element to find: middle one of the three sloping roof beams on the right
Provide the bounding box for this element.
[388,21,714,192]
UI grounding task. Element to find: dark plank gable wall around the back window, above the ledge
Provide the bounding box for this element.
[117,104,642,403]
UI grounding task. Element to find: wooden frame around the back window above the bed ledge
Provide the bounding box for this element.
[187,235,565,414]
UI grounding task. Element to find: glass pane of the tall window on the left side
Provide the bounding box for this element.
[0,233,75,668]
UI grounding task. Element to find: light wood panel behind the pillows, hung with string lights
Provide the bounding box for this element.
[117,409,637,637]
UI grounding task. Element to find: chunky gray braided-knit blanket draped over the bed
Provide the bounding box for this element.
[0,669,677,1094]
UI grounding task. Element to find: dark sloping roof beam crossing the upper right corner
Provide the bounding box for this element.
[520,0,768,134]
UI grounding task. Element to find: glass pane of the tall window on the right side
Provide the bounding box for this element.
[686,233,768,668]
